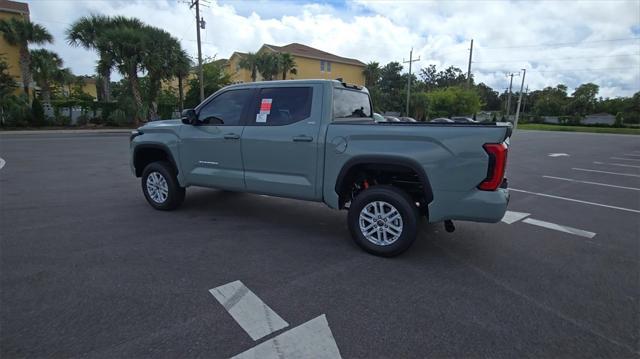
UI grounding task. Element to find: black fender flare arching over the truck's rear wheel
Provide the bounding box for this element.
[334,155,433,204]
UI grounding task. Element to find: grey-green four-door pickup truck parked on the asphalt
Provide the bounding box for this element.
[130,80,511,256]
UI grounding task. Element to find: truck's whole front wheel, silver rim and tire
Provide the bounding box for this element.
[142,161,185,211]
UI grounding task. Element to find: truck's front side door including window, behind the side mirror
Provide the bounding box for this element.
[180,89,255,190]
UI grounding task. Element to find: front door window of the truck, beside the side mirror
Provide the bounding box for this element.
[198,89,251,126]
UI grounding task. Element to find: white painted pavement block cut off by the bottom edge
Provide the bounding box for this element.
[232,314,341,359]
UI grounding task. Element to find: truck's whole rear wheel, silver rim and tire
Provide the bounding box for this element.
[348,186,418,257]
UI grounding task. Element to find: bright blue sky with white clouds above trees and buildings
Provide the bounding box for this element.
[22,0,640,98]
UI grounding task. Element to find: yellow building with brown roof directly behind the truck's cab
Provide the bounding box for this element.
[227,43,365,86]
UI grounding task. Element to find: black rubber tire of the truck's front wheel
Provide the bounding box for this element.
[141,161,185,211]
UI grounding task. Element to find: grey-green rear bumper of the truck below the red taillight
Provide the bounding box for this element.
[429,187,509,223]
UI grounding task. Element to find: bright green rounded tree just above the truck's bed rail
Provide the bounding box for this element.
[427,87,481,118]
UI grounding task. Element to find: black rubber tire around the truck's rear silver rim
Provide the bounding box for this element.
[347,186,419,257]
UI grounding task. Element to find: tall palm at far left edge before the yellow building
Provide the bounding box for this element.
[0,17,53,96]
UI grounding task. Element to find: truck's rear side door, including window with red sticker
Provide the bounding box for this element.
[241,84,323,200]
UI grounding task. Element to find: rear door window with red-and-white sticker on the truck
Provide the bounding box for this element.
[251,87,313,126]
